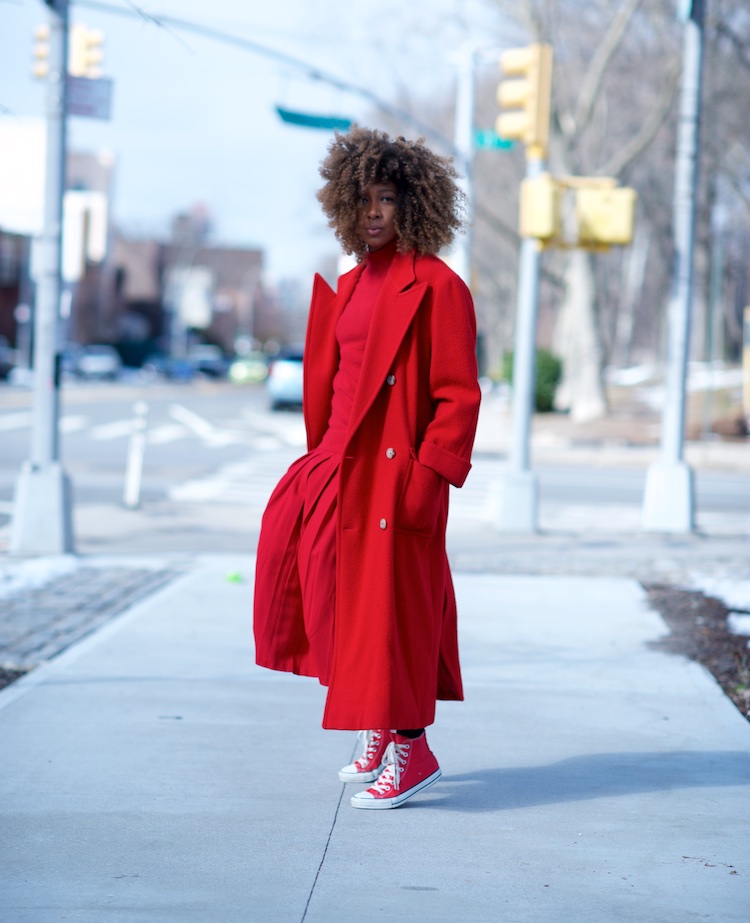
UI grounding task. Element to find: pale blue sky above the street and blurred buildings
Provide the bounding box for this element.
[0,0,512,282]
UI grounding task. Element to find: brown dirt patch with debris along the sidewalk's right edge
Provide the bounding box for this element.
[645,584,750,720]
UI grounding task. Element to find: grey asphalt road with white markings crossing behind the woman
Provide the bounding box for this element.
[0,381,750,525]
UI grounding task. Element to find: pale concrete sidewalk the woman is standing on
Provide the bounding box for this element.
[0,556,750,923]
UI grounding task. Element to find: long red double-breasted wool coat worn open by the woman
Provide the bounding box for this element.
[255,253,480,729]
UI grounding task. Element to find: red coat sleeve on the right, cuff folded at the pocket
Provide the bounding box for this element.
[417,270,481,487]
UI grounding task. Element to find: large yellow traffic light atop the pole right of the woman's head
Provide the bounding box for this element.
[495,44,552,150]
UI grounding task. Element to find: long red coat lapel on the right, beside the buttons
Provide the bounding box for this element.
[344,253,427,438]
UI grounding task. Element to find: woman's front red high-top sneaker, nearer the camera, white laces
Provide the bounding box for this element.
[352,732,441,809]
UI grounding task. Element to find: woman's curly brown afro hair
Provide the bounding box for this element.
[318,125,464,260]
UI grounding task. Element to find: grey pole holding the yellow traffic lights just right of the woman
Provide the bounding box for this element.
[495,145,545,533]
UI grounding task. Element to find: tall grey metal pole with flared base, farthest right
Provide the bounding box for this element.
[642,0,705,532]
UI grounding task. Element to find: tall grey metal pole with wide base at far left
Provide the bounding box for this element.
[10,0,73,555]
